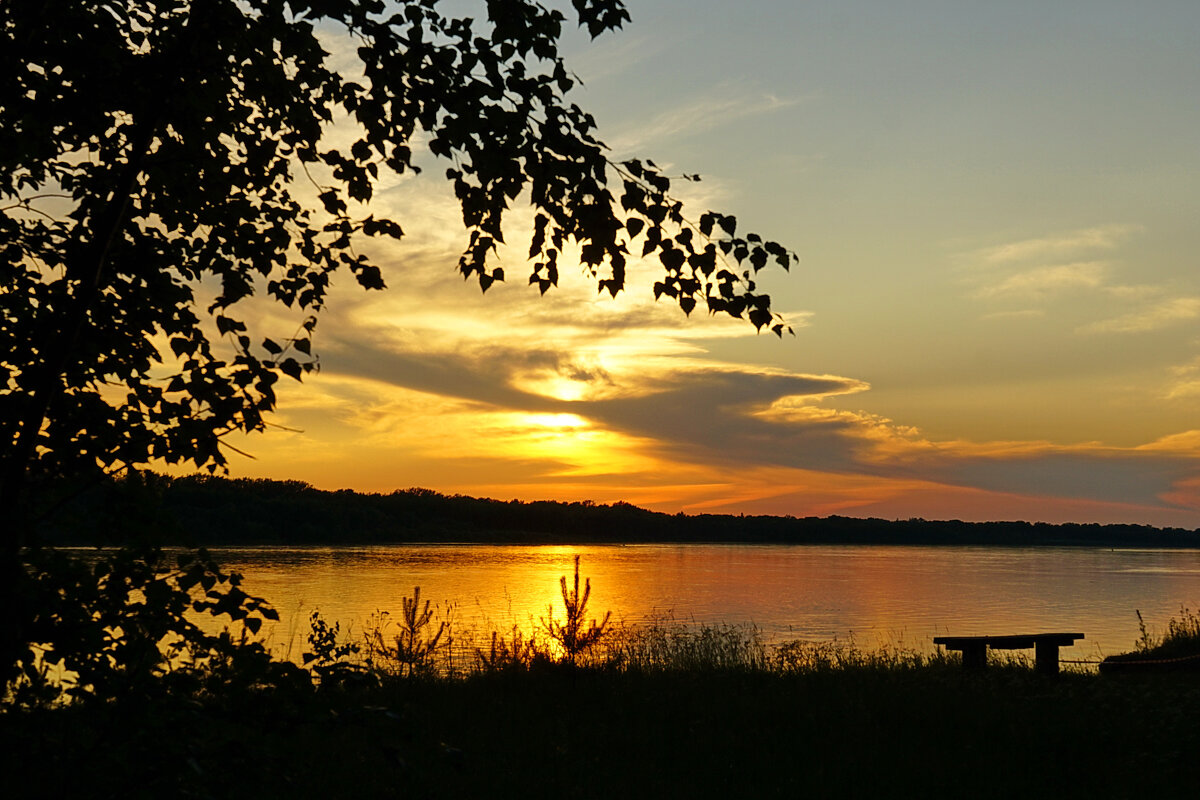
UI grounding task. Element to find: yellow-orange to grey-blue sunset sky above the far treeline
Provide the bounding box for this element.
[223,0,1200,528]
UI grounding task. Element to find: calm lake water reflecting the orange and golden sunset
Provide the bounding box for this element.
[216,545,1200,658]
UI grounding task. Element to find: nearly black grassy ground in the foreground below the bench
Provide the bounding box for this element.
[7,664,1200,799]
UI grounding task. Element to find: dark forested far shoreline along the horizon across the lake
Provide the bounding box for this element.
[35,473,1200,547]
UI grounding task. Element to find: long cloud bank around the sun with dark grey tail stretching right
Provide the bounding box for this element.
[307,277,1187,503]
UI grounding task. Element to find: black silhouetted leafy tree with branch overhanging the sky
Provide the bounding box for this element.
[0,0,794,690]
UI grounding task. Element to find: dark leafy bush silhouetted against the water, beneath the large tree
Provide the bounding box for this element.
[0,547,308,708]
